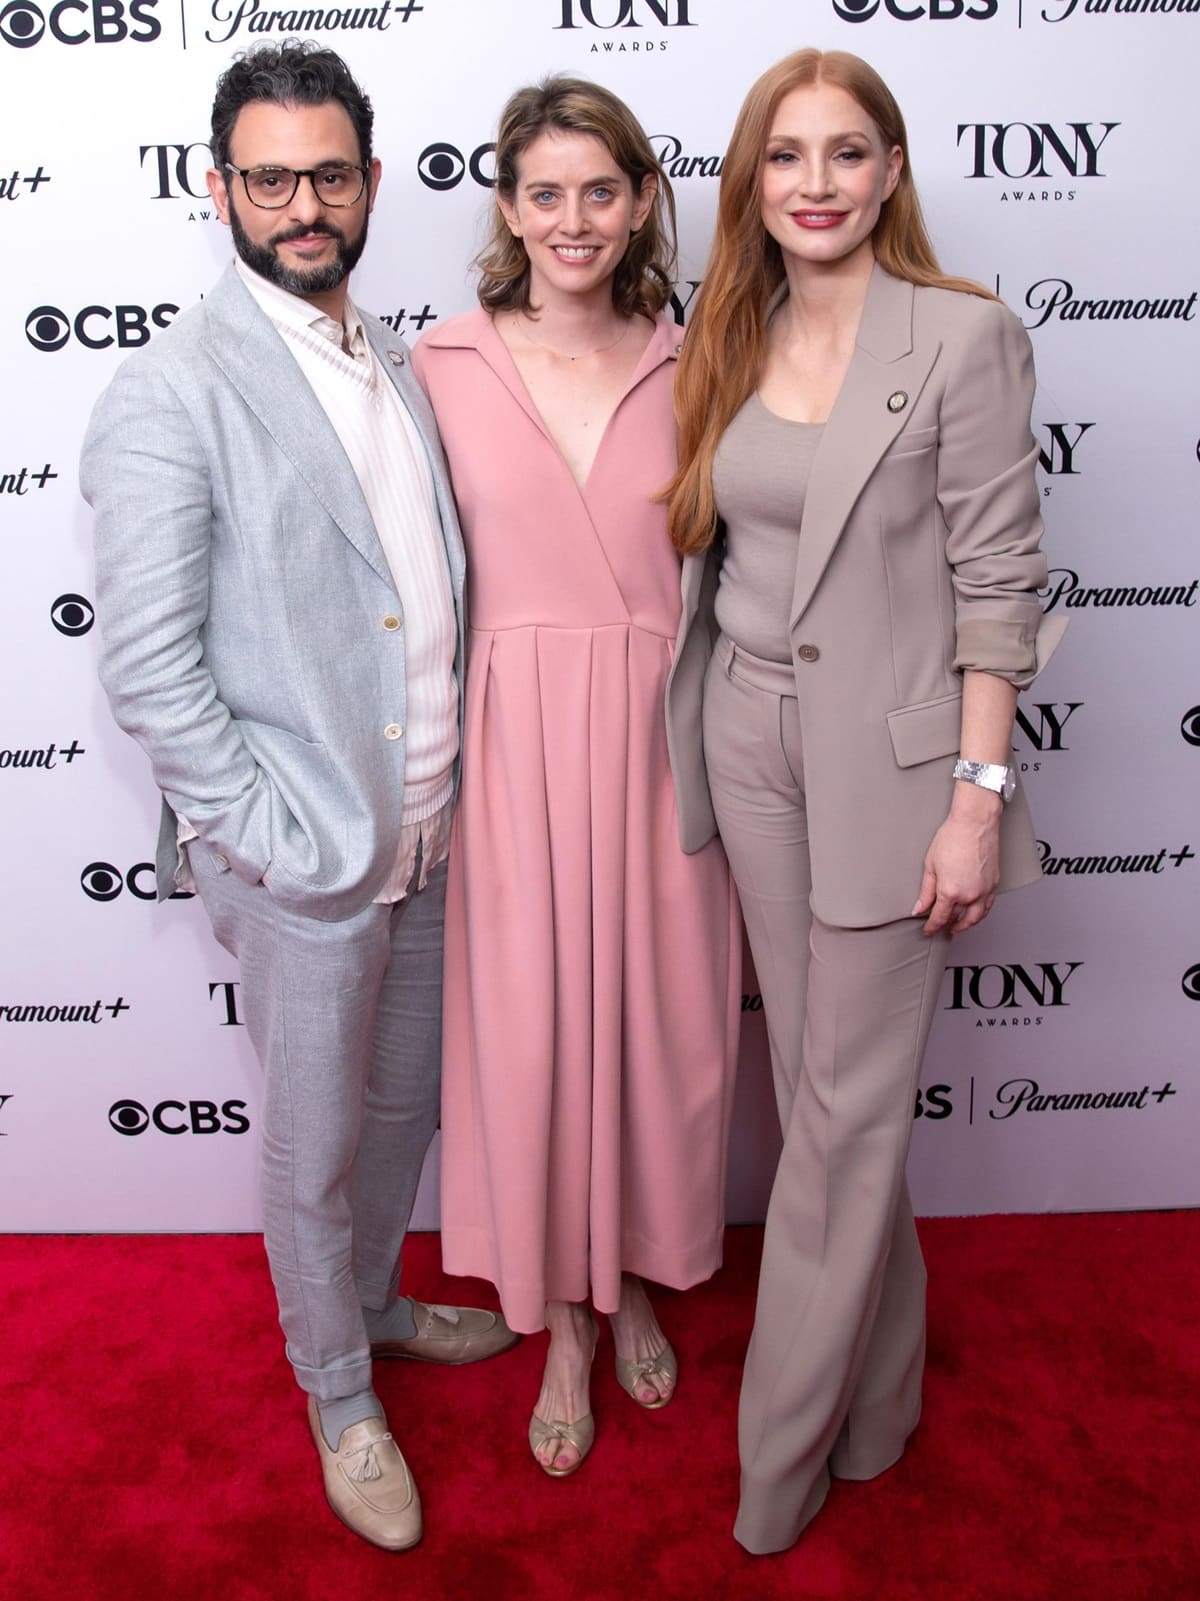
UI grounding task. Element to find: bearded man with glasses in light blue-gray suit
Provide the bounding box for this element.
[82,45,515,1550]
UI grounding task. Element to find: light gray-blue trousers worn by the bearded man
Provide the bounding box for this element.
[189,841,446,1401]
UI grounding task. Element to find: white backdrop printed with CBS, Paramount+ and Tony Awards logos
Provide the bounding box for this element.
[0,0,1200,1230]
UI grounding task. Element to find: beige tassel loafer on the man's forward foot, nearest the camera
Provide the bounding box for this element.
[309,1396,422,1551]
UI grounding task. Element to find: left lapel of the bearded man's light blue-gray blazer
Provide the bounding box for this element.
[205,266,395,588]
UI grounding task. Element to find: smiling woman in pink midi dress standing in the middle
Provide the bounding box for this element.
[414,78,741,1476]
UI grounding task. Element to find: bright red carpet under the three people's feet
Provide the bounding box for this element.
[0,1212,1200,1601]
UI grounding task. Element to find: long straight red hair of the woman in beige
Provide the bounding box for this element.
[664,50,995,554]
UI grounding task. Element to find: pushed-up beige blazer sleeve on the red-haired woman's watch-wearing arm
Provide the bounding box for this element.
[938,296,1062,688]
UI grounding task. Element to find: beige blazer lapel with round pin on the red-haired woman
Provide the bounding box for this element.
[790,264,941,629]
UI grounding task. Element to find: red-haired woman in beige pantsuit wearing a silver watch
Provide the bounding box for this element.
[667,50,1061,1551]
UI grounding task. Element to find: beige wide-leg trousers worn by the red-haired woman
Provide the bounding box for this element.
[704,637,947,1553]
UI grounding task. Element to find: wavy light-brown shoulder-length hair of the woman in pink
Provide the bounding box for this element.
[475,75,675,317]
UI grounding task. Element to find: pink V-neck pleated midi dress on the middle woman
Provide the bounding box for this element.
[414,311,741,1334]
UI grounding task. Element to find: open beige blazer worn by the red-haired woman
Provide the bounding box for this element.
[667,266,1066,927]
